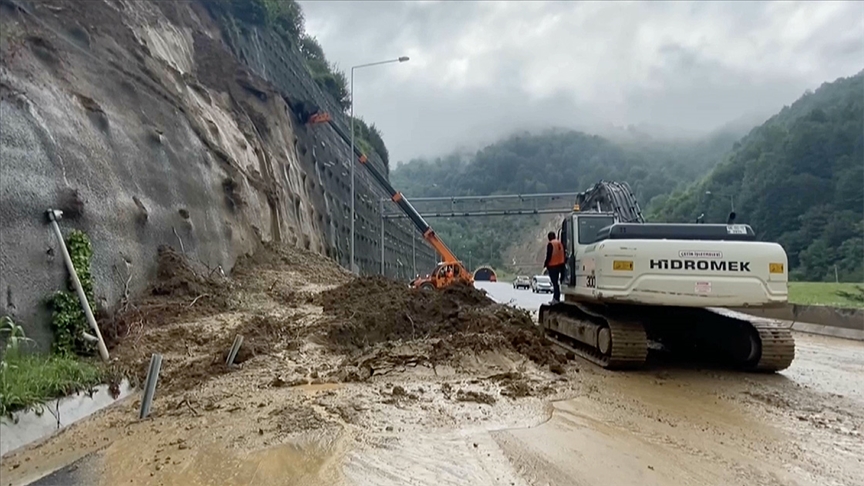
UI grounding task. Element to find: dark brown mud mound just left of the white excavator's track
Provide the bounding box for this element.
[319,276,566,365]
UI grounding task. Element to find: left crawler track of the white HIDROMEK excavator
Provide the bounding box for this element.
[540,304,648,370]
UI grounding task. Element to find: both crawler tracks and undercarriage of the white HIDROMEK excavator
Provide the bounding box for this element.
[539,302,795,373]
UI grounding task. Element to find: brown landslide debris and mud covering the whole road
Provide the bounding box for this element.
[2,245,864,486]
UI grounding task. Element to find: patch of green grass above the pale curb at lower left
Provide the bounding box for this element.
[0,317,102,416]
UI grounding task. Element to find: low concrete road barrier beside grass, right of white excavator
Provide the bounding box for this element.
[732,304,864,341]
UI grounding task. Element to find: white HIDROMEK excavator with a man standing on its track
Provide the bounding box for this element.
[539,181,795,372]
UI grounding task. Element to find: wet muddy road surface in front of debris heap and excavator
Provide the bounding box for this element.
[3,282,864,486]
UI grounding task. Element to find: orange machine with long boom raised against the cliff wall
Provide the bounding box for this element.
[290,101,474,290]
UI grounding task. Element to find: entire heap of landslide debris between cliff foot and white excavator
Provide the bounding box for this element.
[100,244,566,403]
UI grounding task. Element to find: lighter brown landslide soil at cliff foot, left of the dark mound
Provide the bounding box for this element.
[99,243,350,392]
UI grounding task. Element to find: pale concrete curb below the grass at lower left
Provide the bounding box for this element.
[0,380,133,456]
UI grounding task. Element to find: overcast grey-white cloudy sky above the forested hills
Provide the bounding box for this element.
[300,0,864,163]
